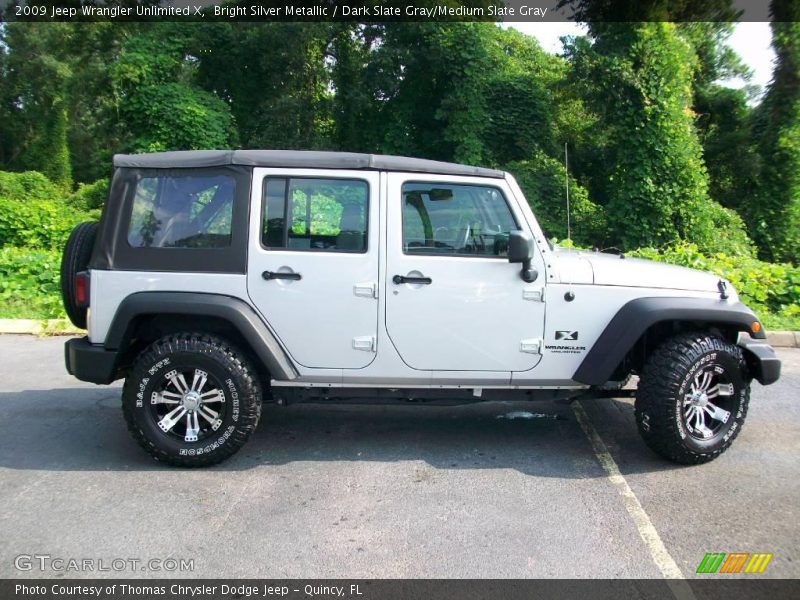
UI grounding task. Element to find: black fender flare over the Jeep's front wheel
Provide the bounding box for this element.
[572,297,766,385]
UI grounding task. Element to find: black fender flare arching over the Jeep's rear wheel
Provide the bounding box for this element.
[103,292,298,381]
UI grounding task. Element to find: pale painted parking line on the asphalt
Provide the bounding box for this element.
[572,400,695,600]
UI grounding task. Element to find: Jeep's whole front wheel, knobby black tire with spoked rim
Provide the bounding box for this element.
[636,333,750,465]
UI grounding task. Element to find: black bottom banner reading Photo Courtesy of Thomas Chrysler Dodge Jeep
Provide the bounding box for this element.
[0,577,800,600]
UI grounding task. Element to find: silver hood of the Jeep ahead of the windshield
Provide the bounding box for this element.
[554,249,733,293]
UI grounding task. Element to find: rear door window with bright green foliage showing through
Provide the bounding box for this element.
[261,177,369,252]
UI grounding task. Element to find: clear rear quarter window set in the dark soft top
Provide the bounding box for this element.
[128,175,235,248]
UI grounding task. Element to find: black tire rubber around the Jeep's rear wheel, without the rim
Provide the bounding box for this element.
[122,332,261,467]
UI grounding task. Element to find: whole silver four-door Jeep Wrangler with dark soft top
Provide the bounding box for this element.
[62,150,780,466]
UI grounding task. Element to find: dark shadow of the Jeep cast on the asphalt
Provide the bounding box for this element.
[0,387,680,479]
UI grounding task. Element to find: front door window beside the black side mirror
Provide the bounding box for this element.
[402,183,519,256]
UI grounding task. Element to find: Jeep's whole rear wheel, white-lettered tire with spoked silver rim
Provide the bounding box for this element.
[122,333,261,467]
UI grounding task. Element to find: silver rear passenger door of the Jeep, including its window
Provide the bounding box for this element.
[247,169,380,369]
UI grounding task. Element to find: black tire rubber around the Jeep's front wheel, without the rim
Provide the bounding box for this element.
[635,333,750,465]
